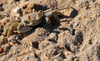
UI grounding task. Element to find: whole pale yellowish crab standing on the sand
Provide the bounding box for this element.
[3,8,65,38]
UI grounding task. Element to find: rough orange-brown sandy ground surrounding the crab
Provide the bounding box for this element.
[0,0,100,61]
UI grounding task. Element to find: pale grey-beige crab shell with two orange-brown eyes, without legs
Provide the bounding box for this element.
[21,12,43,26]
